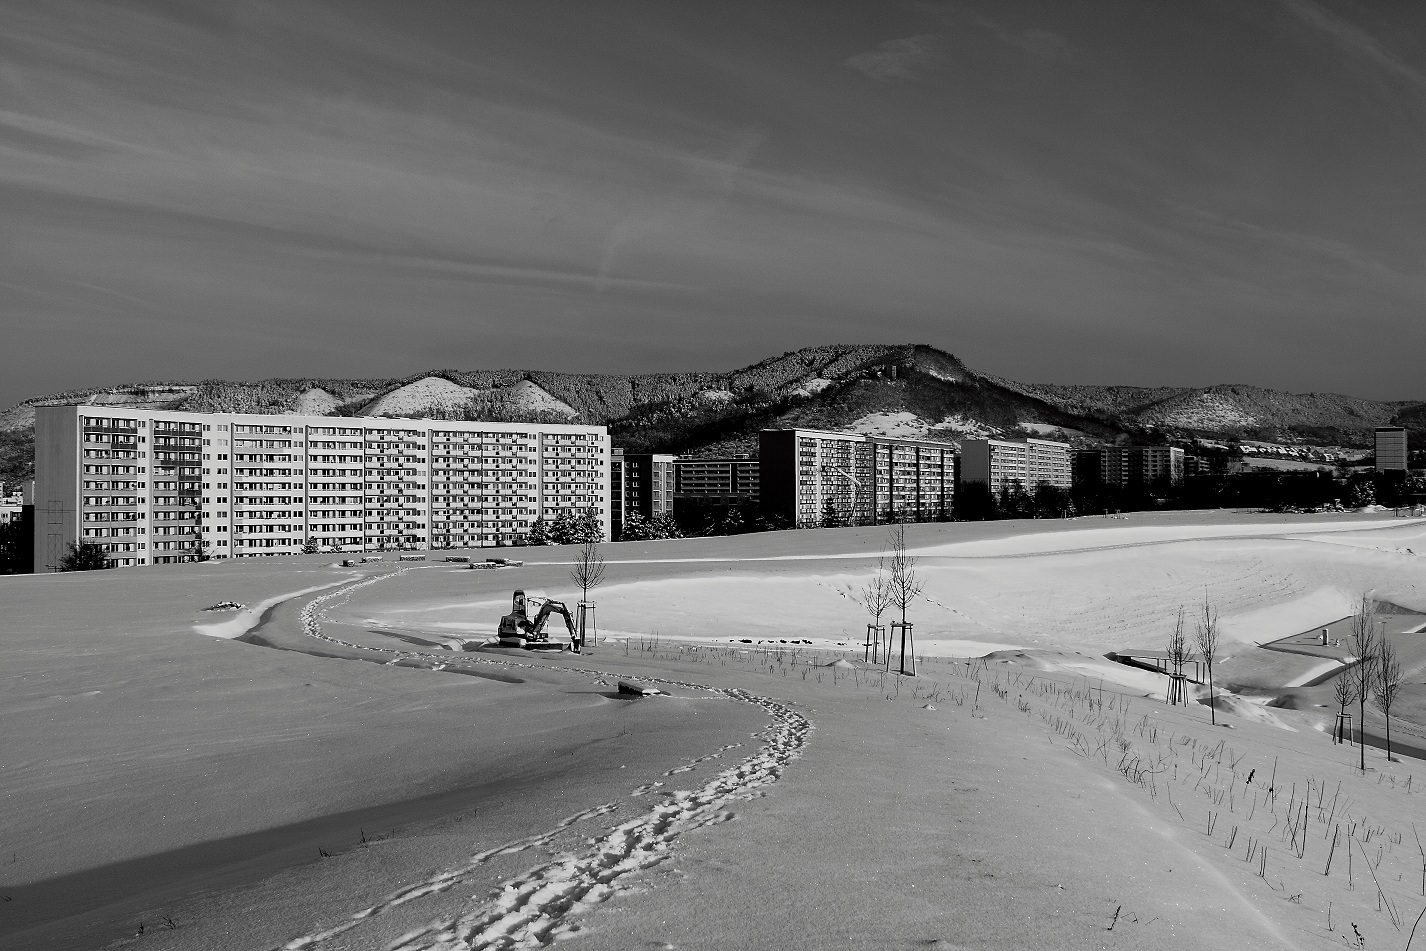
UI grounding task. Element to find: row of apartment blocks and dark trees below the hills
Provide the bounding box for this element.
[0,403,1426,573]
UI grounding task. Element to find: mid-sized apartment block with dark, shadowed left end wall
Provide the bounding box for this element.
[759,429,955,528]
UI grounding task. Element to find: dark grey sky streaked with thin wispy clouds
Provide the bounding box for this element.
[0,0,1426,406]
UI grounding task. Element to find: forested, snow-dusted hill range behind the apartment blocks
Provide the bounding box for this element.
[0,344,1426,480]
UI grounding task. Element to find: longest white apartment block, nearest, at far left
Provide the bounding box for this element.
[34,405,610,572]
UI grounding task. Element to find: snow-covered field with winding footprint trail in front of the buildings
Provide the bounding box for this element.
[0,513,1426,950]
